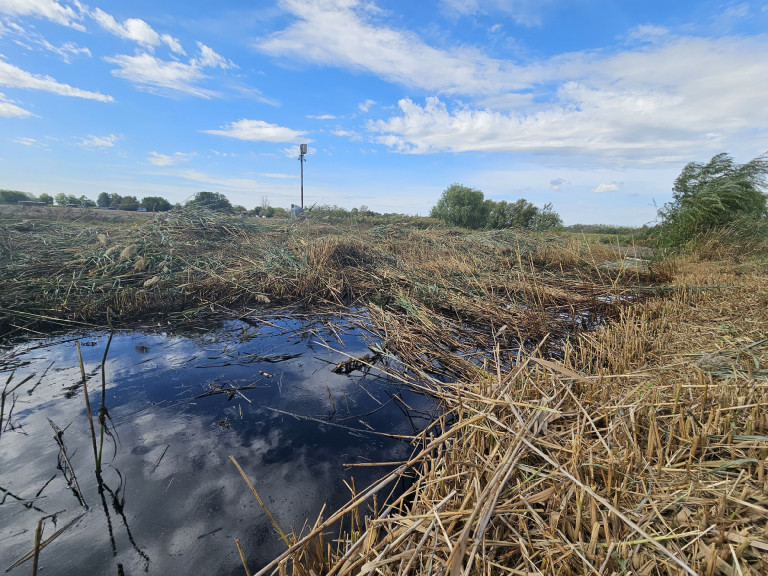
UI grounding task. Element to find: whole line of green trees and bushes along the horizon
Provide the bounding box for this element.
[0,153,768,249]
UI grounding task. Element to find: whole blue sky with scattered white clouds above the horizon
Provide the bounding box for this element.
[0,0,768,225]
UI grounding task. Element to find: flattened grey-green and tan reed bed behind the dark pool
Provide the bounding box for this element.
[0,210,658,337]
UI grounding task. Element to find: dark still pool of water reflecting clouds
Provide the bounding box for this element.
[0,318,436,575]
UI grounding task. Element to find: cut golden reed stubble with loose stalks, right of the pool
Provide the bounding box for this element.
[249,260,768,576]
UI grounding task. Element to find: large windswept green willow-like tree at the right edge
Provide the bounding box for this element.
[659,153,768,247]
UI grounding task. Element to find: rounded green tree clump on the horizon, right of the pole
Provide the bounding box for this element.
[429,184,563,231]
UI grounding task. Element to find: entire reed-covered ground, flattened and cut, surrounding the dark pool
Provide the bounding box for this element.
[0,205,768,575]
